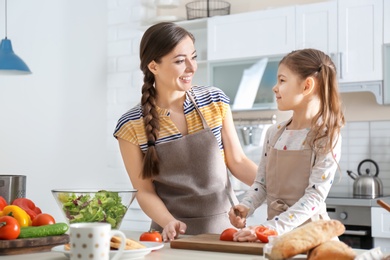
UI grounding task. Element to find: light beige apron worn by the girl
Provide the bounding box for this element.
[265,120,329,221]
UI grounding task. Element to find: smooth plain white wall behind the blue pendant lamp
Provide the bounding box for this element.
[0,0,130,223]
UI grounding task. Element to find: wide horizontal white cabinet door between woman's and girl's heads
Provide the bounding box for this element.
[207,7,295,60]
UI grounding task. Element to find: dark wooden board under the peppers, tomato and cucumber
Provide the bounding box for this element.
[0,234,69,255]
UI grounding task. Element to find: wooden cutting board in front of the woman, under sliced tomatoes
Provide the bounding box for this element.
[171,234,266,255]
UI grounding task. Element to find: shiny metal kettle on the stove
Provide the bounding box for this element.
[347,159,383,198]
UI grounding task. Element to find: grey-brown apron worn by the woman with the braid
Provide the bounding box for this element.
[151,92,238,235]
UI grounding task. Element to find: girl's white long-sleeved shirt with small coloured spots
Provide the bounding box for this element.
[240,124,341,234]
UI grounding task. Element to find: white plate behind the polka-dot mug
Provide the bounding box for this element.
[51,242,164,260]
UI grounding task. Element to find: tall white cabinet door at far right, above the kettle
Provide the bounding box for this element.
[338,0,383,83]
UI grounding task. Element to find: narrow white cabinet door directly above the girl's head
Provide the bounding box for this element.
[296,1,337,56]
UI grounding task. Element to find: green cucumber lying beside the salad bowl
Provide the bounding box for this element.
[18,223,69,238]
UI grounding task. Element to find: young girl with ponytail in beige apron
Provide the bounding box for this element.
[229,49,344,241]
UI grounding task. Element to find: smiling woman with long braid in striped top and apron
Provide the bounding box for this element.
[114,22,257,241]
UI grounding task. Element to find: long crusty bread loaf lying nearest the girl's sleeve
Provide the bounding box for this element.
[268,220,345,260]
